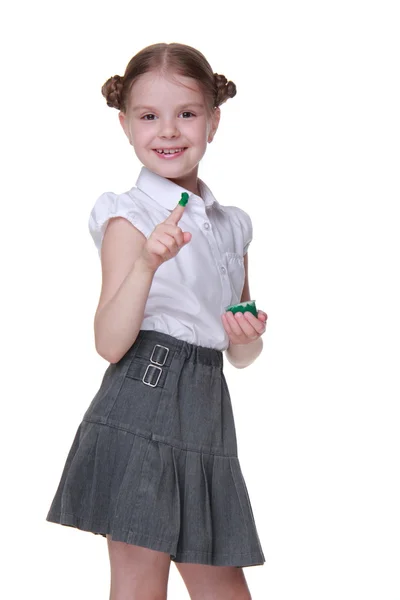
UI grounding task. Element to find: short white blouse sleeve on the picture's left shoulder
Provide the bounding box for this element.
[89,192,153,256]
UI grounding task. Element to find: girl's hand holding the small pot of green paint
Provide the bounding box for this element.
[221,310,268,345]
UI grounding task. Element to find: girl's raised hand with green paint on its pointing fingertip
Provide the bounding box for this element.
[141,204,192,272]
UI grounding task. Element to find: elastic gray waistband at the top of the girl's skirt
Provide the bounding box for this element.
[126,329,223,367]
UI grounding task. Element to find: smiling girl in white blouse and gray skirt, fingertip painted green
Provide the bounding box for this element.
[47,43,267,600]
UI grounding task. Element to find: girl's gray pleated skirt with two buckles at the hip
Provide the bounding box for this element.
[46,330,265,567]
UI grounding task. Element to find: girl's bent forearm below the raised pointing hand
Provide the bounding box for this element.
[94,258,154,363]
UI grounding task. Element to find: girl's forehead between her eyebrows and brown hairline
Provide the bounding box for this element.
[130,72,204,106]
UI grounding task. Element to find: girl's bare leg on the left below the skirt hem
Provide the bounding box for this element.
[107,535,171,600]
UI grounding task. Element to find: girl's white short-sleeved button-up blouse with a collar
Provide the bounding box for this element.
[89,167,253,350]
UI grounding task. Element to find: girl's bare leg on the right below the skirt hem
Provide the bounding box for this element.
[175,562,251,600]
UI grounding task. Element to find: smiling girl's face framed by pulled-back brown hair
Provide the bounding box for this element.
[119,72,220,193]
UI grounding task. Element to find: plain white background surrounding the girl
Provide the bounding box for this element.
[1,0,400,600]
